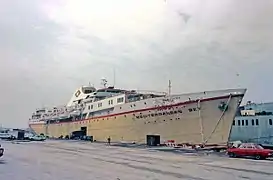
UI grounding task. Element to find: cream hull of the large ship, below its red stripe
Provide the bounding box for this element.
[30,94,244,144]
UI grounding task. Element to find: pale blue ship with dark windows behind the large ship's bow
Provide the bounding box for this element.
[230,101,273,145]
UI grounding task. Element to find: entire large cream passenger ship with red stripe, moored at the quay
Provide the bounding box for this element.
[29,81,246,144]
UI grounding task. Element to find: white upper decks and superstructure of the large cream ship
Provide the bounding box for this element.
[30,87,246,122]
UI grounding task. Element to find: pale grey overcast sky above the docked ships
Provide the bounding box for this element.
[0,0,273,127]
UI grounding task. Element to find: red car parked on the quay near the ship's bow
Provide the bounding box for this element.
[227,143,273,160]
